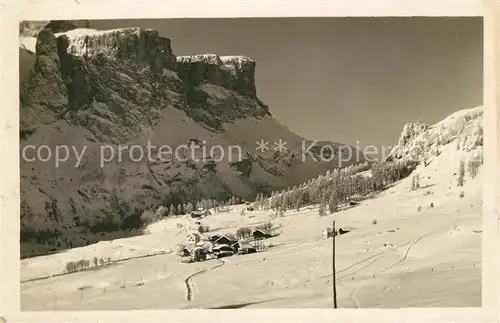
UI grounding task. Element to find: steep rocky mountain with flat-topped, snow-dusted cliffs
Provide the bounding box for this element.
[19,21,364,256]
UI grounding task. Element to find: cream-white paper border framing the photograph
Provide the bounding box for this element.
[0,0,500,323]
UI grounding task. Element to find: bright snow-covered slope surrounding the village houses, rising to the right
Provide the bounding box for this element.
[21,107,483,310]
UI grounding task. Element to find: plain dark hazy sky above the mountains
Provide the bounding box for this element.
[91,17,483,147]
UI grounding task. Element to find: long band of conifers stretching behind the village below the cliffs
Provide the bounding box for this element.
[138,161,412,223]
